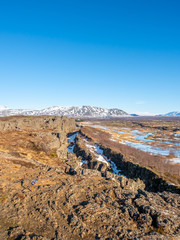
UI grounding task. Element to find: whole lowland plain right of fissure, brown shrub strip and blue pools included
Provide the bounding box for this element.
[81,117,180,185]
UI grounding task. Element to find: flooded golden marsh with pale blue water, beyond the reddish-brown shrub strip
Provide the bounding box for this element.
[83,118,180,163]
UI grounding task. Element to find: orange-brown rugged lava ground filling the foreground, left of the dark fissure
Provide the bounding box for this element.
[0,116,180,240]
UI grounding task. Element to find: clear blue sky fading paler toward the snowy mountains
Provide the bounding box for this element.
[0,0,180,113]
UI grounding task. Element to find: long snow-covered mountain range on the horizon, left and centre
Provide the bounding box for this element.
[0,106,130,118]
